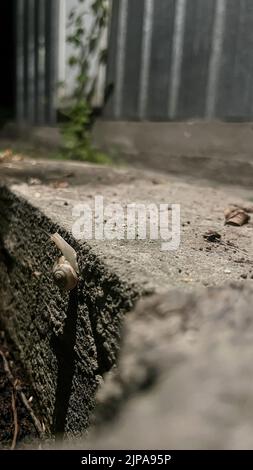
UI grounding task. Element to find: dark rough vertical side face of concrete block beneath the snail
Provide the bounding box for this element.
[0,185,137,433]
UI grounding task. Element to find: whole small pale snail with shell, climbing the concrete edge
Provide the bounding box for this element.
[50,233,79,291]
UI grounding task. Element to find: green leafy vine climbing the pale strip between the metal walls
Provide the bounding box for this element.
[62,0,110,163]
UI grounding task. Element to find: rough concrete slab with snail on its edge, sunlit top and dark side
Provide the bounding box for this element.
[0,160,253,440]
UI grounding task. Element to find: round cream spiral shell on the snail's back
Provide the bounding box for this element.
[53,256,78,291]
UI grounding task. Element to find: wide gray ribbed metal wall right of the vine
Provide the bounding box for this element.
[105,0,253,120]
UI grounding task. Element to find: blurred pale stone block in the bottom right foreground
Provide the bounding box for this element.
[88,285,253,449]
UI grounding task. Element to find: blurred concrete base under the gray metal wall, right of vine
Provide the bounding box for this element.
[94,121,253,187]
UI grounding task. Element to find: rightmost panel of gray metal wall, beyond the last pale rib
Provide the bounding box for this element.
[216,0,253,120]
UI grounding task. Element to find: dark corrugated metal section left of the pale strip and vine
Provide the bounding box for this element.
[16,0,59,125]
